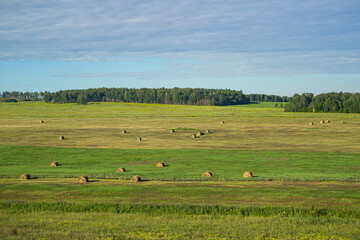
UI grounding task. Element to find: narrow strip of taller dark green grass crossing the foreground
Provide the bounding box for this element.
[0,201,360,219]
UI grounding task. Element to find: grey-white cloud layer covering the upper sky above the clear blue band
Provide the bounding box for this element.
[0,0,360,61]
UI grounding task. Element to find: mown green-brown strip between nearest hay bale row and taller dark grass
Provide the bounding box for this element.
[0,178,360,210]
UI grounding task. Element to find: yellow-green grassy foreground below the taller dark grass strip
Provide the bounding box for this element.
[0,210,360,240]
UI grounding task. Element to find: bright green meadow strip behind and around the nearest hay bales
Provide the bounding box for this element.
[0,145,360,182]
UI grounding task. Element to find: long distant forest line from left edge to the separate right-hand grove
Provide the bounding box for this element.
[0,88,289,106]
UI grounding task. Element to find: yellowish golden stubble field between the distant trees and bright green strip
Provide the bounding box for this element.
[0,103,360,152]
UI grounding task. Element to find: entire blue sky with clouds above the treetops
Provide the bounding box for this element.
[0,0,360,96]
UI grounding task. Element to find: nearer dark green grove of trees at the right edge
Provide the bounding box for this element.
[285,92,360,113]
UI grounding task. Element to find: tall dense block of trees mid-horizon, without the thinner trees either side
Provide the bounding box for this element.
[44,88,250,106]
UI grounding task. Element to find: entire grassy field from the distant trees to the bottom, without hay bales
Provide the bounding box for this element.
[0,102,360,239]
